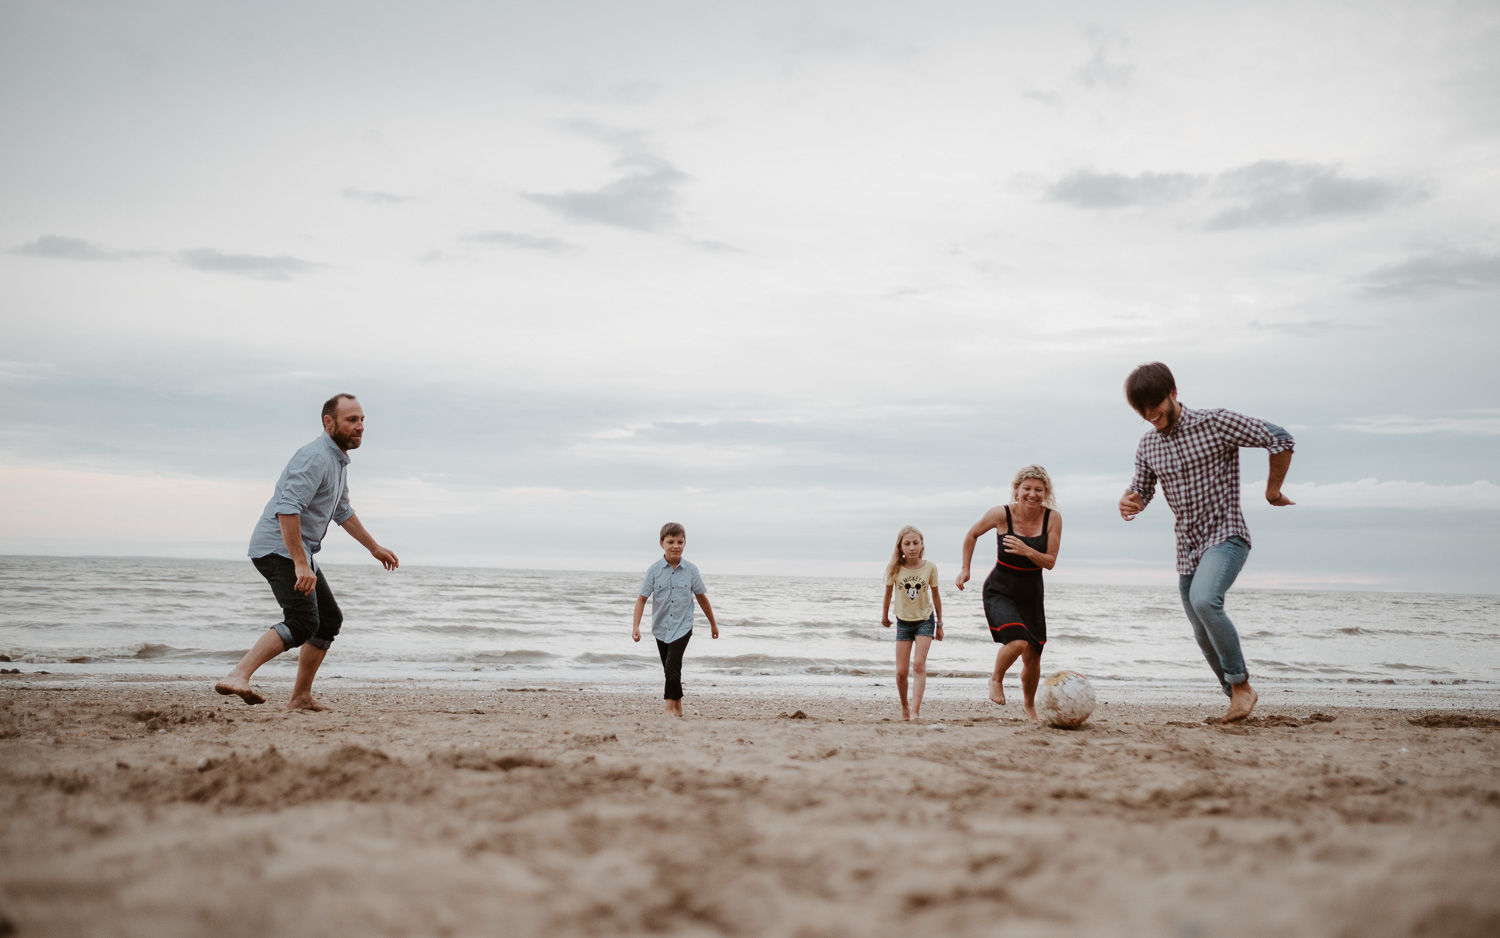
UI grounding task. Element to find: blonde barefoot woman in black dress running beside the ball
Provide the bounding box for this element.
[957,465,1062,720]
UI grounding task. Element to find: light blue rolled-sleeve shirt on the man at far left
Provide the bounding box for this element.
[251,434,354,569]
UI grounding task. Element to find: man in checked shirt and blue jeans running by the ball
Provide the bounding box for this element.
[1121,362,1293,723]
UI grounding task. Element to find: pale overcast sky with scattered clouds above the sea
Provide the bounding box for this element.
[0,0,1500,593]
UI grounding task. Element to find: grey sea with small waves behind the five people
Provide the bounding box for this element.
[0,555,1500,707]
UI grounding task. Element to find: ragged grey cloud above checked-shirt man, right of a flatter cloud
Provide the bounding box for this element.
[1205,161,1406,231]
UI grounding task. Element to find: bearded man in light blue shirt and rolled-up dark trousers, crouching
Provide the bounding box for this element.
[213,393,399,710]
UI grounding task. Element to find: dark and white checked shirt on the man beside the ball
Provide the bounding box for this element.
[1130,407,1293,575]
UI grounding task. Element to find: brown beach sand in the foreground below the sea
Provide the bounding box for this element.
[0,675,1500,938]
